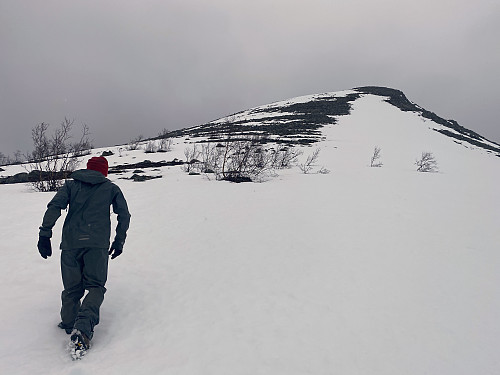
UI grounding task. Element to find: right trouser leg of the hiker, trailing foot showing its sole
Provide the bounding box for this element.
[75,248,109,339]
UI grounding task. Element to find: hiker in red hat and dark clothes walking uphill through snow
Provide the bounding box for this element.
[37,156,130,351]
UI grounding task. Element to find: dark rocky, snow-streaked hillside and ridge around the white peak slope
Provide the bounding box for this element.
[164,86,500,155]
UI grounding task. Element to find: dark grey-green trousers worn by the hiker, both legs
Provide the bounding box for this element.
[61,248,108,339]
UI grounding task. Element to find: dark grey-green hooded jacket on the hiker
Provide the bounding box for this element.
[40,169,130,250]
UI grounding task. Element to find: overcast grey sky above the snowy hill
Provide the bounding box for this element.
[0,0,500,154]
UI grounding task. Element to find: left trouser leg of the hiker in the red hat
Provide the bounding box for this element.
[61,249,85,329]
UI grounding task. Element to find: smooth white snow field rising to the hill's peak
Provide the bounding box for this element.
[0,95,500,375]
